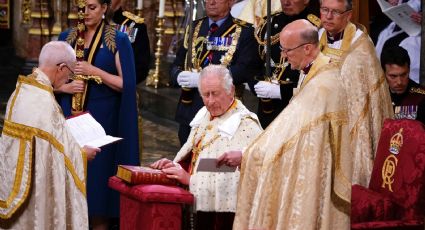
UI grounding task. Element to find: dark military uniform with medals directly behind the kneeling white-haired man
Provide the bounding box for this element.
[170,15,261,144]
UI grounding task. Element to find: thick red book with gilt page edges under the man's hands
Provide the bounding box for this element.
[117,165,177,185]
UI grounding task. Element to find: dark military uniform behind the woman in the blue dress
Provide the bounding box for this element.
[112,8,150,84]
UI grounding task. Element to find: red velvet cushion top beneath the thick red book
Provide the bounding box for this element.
[108,176,194,204]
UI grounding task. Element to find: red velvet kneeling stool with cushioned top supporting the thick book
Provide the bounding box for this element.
[108,176,194,230]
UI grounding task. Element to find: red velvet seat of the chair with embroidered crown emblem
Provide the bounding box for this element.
[351,185,399,223]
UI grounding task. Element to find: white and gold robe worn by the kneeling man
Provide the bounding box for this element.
[174,99,262,212]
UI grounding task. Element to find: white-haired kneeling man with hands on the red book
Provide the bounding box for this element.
[151,65,262,229]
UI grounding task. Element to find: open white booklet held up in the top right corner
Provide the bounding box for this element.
[378,0,421,36]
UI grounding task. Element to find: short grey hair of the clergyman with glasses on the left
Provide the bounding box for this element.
[38,41,76,67]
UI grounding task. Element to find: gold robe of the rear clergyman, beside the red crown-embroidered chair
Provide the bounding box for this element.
[320,23,393,186]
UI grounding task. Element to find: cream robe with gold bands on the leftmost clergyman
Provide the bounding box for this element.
[0,69,88,229]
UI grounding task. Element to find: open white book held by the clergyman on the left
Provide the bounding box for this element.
[66,113,122,147]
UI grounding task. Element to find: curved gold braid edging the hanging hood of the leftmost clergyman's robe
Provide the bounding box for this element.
[0,138,34,219]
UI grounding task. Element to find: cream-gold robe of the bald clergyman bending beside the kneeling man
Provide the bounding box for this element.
[233,54,351,230]
